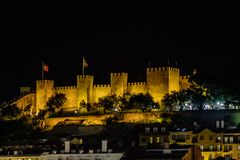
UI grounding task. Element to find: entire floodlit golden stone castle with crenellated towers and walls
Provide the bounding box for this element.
[16,67,189,113]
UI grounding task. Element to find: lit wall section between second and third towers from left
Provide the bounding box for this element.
[92,84,111,103]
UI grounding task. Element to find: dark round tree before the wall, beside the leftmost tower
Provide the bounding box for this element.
[47,93,67,113]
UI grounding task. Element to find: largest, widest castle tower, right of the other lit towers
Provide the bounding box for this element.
[147,67,179,102]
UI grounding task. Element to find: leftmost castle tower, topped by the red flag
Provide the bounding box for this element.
[36,80,54,113]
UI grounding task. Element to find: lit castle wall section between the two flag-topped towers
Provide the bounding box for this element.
[54,86,79,111]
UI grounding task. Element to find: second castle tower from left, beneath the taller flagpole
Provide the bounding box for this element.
[77,75,93,106]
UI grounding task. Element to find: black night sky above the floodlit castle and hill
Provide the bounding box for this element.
[0,0,240,101]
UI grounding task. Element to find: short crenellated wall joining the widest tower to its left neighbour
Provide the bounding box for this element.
[127,82,147,94]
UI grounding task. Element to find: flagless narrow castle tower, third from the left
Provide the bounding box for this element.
[110,72,128,96]
